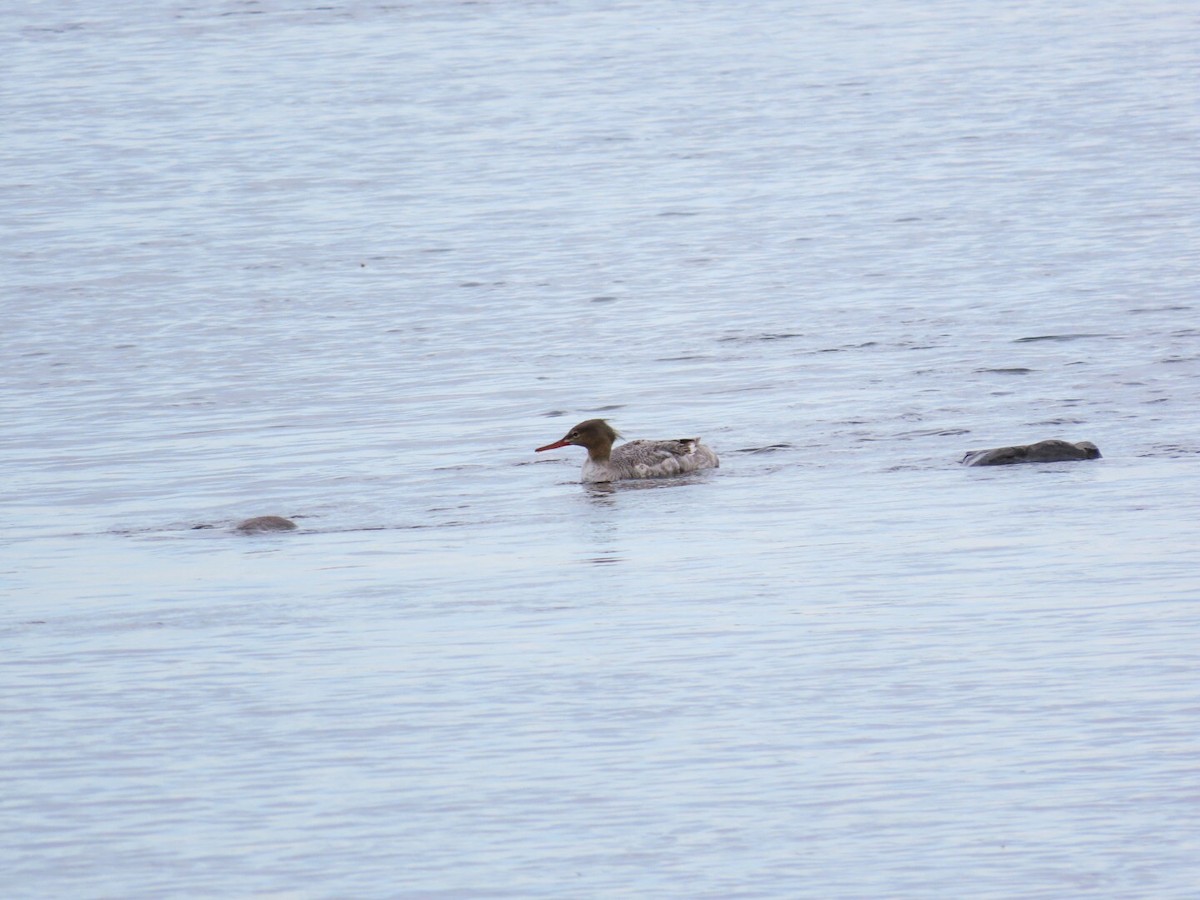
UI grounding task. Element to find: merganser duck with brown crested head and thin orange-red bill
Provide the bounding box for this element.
[534,419,721,484]
